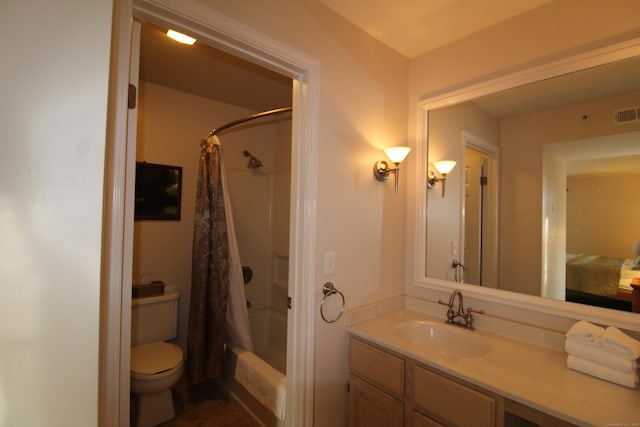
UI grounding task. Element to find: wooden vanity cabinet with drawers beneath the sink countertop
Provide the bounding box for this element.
[349,336,572,427]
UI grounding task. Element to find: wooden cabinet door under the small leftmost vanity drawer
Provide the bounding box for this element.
[349,375,403,427]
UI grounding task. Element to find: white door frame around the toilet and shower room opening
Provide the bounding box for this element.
[99,0,320,426]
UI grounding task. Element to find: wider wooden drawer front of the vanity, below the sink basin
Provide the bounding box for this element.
[413,366,496,427]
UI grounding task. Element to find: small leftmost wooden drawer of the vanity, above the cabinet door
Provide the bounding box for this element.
[349,339,404,397]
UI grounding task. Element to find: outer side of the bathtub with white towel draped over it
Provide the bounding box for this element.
[225,345,286,427]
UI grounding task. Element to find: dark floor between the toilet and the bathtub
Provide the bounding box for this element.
[131,380,256,427]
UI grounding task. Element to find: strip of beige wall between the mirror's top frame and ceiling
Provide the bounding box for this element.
[410,0,640,100]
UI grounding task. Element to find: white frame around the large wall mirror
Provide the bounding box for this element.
[408,38,640,332]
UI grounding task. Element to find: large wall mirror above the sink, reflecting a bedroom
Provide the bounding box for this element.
[417,40,640,320]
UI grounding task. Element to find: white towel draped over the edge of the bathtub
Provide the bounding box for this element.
[234,351,287,420]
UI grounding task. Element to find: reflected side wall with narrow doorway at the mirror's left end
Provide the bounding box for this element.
[425,112,500,287]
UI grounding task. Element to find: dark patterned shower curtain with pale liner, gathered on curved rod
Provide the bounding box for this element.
[187,136,253,384]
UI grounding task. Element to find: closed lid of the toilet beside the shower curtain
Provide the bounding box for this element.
[131,342,182,375]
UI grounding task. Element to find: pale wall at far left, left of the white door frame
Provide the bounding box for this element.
[0,0,112,426]
